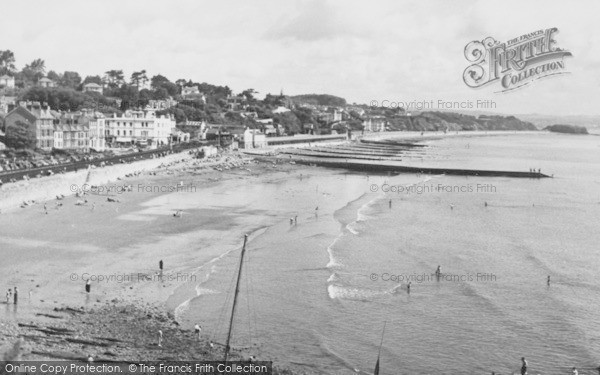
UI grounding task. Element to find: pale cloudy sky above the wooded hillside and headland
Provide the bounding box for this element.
[0,0,600,115]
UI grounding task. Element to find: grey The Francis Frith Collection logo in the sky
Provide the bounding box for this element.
[463,27,571,92]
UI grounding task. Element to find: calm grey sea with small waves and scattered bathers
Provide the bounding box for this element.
[180,134,600,374]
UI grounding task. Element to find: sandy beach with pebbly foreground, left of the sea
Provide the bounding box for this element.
[0,146,318,370]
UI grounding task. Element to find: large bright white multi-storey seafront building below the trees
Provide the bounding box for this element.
[105,111,175,146]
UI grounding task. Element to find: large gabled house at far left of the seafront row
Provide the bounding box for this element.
[4,102,54,150]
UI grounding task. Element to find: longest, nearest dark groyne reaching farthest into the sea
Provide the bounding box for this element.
[286,158,552,178]
